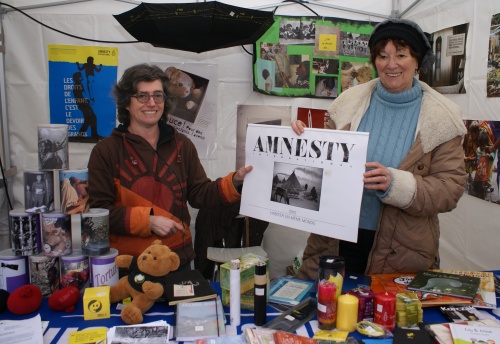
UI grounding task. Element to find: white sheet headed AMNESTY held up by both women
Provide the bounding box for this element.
[240,124,368,242]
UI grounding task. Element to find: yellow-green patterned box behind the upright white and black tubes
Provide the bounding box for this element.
[220,253,269,310]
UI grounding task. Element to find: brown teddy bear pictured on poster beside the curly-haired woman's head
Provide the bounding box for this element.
[165,67,203,112]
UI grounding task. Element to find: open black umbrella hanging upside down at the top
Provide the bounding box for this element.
[114,1,274,53]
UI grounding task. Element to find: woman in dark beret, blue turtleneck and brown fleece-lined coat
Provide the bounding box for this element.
[292,19,466,279]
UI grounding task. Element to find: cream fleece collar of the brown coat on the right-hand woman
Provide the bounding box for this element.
[328,79,466,153]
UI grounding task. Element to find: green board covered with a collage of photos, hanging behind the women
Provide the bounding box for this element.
[253,16,377,99]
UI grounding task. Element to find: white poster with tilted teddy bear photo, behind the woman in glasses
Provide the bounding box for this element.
[155,62,217,159]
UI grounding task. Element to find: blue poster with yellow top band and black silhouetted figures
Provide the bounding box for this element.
[48,44,118,142]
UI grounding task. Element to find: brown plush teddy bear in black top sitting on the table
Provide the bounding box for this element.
[110,240,180,325]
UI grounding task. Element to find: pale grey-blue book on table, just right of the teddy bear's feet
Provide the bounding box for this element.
[175,297,226,342]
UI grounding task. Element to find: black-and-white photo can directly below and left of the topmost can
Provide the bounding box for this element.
[24,171,55,213]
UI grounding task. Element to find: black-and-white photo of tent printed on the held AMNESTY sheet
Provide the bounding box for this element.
[271,161,323,211]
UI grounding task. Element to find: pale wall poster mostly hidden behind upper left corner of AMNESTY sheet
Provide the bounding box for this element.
[235,104,292,169]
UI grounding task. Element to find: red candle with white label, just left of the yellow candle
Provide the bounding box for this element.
[318,280,337,330]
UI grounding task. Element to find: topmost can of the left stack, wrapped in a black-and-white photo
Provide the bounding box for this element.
[38,124,69,170]
